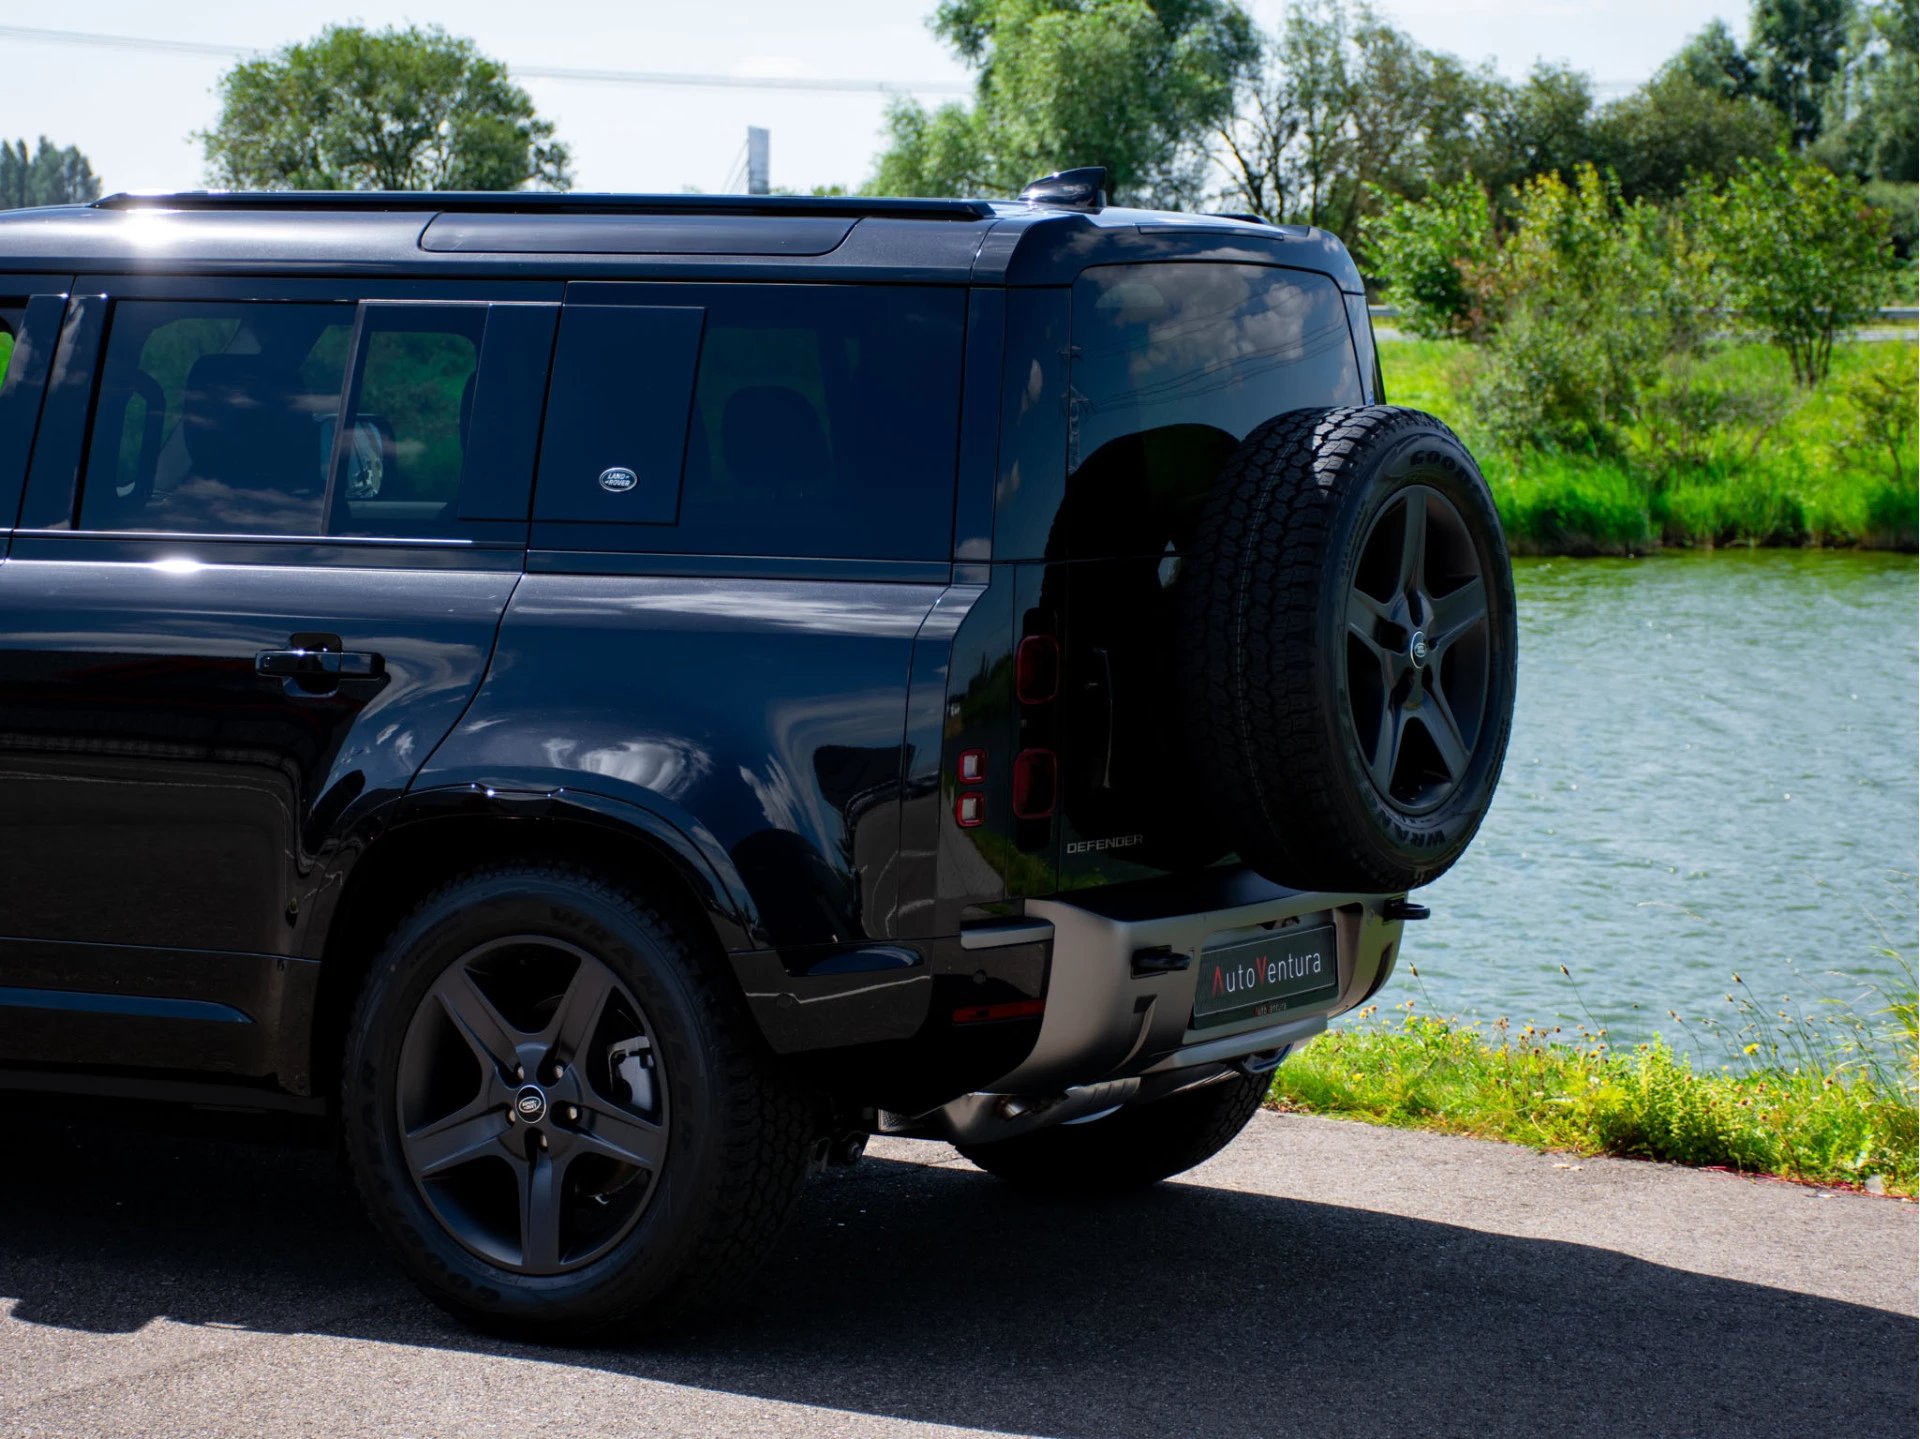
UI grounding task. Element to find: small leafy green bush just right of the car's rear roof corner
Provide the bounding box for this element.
[1361,181,1496,338]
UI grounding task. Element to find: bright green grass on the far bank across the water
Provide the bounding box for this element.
[1380,340,1920,553]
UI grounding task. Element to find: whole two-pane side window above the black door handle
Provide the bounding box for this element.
[81,300,486,538]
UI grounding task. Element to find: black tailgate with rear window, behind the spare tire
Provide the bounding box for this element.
[1052,261,1365,888]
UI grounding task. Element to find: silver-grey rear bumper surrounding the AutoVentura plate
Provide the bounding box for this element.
[887,870,1404,1141]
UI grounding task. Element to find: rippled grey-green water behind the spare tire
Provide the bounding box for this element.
[1380,551,1920,1059]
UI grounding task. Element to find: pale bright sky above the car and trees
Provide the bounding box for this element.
[0,0,1747,192]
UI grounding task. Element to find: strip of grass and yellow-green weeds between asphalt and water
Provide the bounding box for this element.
[1267,964,1920,1195]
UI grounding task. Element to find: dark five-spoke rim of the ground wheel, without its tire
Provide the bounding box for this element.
[396,934,668,1274]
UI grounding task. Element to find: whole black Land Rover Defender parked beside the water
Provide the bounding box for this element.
[0,173,1515,1333]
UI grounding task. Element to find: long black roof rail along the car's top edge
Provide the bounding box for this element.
[92,190,995,219]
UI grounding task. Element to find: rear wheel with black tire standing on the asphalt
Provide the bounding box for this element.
[340,859,824,1339]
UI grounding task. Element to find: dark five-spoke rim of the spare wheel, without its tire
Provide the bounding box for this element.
[1346,484,1492,815]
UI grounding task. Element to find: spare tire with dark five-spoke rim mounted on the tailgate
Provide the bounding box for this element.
[1181,405,1517,893]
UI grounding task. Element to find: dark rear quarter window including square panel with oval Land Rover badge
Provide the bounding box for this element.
[534,284,966,559]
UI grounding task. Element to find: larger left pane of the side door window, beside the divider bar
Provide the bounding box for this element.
[81,300,353,534]
